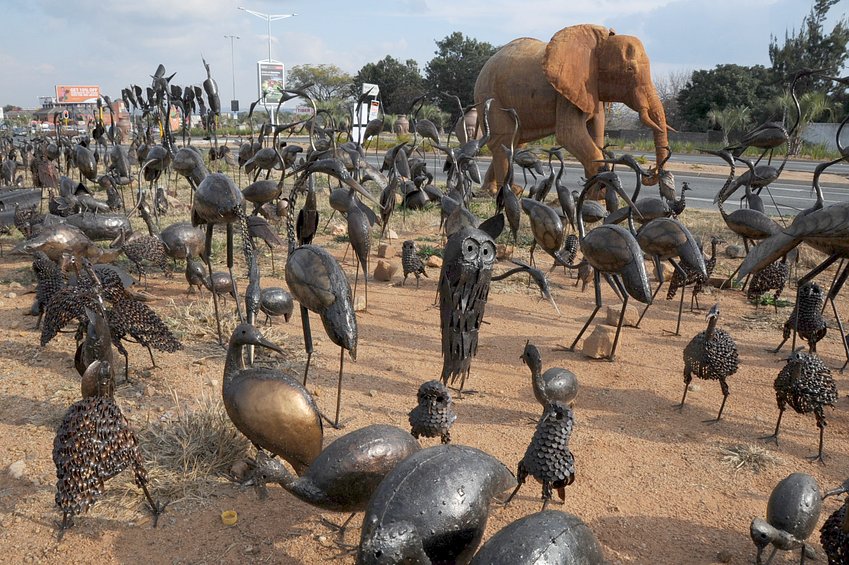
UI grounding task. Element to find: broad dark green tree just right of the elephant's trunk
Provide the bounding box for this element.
[678,64,781,131]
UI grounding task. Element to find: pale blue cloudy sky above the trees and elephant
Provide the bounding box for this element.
[0,0,849,108]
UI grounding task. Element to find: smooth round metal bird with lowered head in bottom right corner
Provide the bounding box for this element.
[749,473,822,565]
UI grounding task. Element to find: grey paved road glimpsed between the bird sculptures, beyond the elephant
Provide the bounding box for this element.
[360,154,849,215]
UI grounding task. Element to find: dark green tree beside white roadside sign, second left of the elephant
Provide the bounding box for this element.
[354,55,425,114]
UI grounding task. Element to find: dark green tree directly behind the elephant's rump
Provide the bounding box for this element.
[425,31,497,115]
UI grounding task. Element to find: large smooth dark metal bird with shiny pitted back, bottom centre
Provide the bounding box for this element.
[356,444,516,565]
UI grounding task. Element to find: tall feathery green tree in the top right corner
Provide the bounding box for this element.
[769,0,849,102]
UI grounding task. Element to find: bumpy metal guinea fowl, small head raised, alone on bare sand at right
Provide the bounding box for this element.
[681,304,740,422]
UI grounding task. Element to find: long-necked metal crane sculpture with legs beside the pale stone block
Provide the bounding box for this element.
[569,172,652,361]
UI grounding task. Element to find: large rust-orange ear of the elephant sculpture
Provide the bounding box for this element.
[542,24,613,114]
